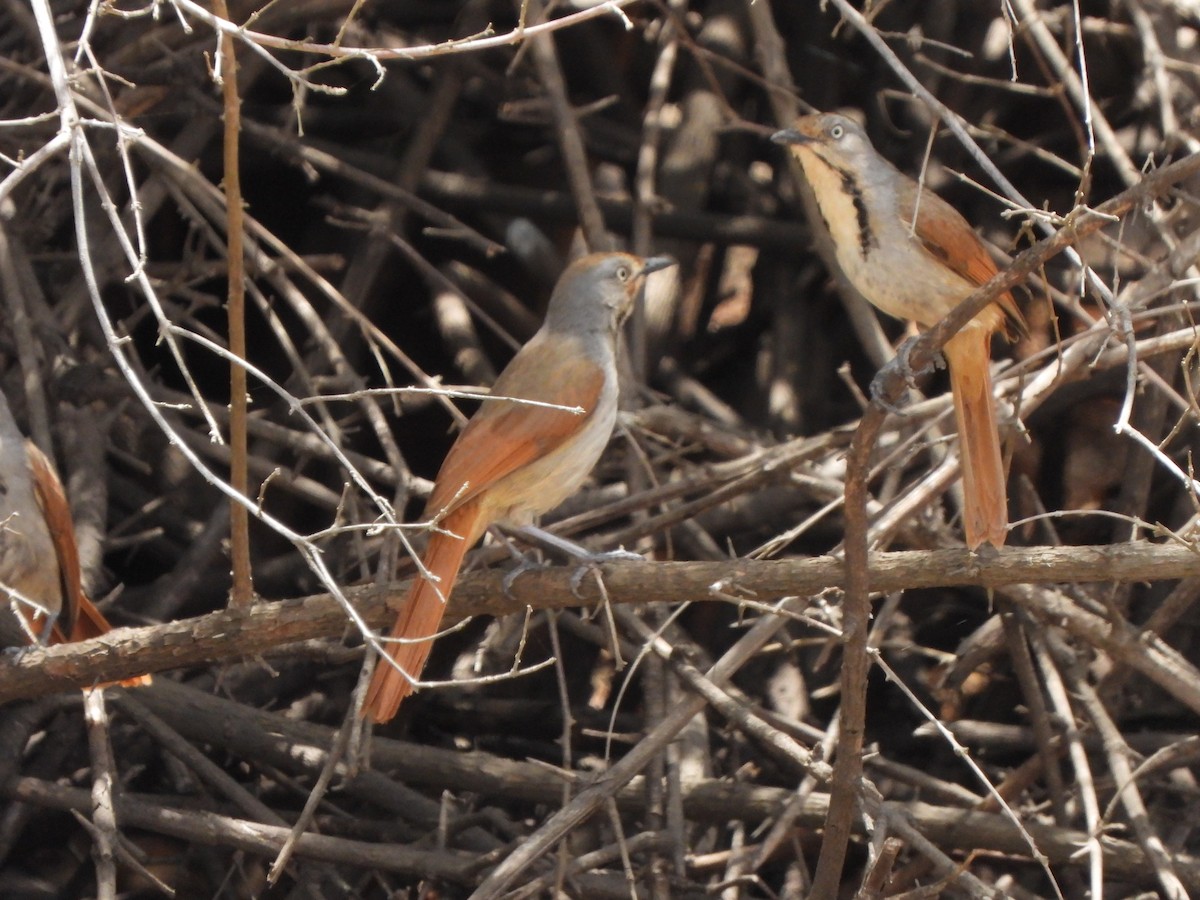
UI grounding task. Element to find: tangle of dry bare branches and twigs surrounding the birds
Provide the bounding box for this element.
[0,0,1200,898]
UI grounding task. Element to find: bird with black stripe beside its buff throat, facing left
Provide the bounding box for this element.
[772,113,1025,551]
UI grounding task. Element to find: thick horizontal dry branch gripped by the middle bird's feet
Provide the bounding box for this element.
[0,542,1200,702]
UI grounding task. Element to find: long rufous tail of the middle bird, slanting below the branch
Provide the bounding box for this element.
[362,503,482,722]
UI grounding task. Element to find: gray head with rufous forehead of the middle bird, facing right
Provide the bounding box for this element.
[544,253,674,334]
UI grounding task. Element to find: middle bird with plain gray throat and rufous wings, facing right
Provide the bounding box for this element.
[362,253,674,722]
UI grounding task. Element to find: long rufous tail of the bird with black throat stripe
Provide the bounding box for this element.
[943,324,1008,550]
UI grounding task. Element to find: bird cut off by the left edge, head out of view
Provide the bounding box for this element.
[0,391,150,688]
